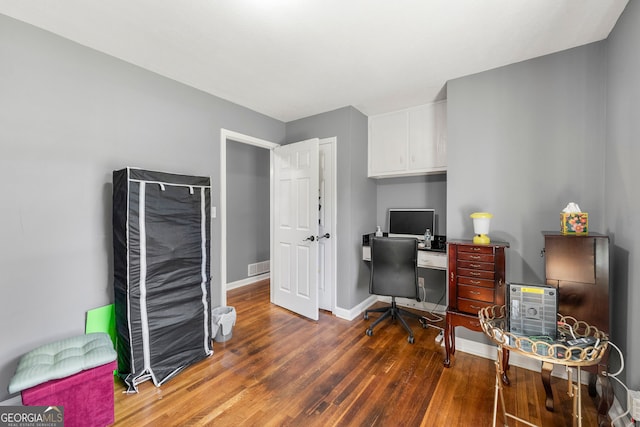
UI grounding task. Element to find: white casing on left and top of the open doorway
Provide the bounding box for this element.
[218,128,279,306]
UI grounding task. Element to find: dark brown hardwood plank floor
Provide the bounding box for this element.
[115,281,597,427]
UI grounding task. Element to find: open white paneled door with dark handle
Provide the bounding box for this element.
[271,138,319,320]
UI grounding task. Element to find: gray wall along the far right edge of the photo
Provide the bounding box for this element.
[604,1,640,392]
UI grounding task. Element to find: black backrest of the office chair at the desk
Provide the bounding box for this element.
[369,237,418,299]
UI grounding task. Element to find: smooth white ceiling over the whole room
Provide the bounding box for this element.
[0,0,628,122]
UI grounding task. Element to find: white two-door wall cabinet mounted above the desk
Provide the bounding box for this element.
[368,101,447,178]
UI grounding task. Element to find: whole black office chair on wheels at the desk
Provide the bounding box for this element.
[364,237,426,344]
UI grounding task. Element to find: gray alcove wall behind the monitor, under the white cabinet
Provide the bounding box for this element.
[376,174,447,305]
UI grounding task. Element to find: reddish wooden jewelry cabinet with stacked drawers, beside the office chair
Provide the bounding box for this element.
[444,240,509,367]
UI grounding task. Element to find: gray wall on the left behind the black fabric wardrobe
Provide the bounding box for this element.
[0,15,285,400]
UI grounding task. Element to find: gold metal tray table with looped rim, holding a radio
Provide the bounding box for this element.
[478,305,608,427]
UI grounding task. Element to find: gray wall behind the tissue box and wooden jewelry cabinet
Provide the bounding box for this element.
[447,42,607,340]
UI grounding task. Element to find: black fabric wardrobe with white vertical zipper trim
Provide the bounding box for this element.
[113,168,213,391]
